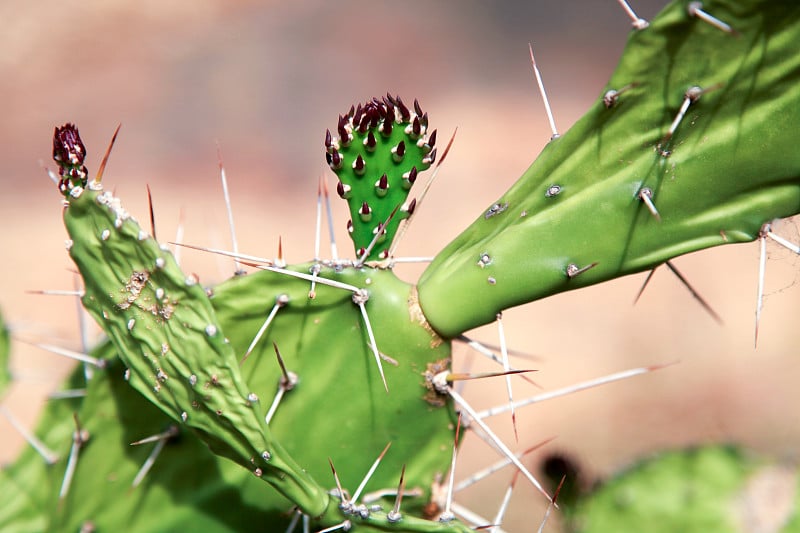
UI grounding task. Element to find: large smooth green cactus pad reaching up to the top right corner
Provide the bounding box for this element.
[419,1,800,337]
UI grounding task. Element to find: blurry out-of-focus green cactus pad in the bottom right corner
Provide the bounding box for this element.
[565,446,800,533]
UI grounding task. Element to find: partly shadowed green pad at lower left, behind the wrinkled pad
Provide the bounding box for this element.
[0,342,465,533]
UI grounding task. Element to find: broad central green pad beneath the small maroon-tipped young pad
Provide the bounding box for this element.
[211,264,464,531]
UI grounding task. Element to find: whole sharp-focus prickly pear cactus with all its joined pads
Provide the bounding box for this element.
[0,1,800,532]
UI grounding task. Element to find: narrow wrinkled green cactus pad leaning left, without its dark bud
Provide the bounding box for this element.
[58,182,328,516]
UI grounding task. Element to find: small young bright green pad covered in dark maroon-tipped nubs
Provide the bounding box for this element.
[325,94,436,260]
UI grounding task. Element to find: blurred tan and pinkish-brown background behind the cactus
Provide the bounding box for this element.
[0,0,800,530]
